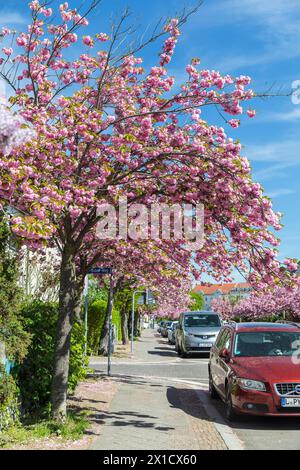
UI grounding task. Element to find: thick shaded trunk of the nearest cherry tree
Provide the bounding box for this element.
[51,247,78,422]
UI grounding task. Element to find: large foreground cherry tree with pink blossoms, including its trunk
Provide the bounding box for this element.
[0,0,292,420]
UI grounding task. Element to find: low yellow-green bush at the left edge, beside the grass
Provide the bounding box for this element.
[0,366,19,432]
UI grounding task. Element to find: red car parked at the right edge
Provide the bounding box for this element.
[208,322,300,420]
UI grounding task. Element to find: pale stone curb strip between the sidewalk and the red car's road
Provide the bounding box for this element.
[193,387,245,450]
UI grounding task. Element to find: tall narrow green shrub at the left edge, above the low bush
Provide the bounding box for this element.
[0,216,30,362]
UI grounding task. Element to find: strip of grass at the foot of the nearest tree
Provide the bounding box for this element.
[0,412,89,448]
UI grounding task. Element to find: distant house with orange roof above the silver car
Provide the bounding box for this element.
[194,282,252,310]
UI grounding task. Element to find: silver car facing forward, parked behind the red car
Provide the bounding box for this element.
[175,310,222,357]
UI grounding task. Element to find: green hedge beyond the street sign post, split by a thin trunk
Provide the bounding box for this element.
[88,299,122,354]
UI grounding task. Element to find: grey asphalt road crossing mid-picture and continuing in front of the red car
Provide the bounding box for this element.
[91,330,300,450]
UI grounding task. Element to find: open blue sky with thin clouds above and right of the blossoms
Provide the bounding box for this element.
[0,0,300,268]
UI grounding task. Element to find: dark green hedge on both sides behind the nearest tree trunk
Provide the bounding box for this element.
[15,301,88,415]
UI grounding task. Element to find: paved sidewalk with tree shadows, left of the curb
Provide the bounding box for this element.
[91,332,227,450]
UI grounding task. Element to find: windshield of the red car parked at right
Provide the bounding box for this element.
[234,331,300,357]
